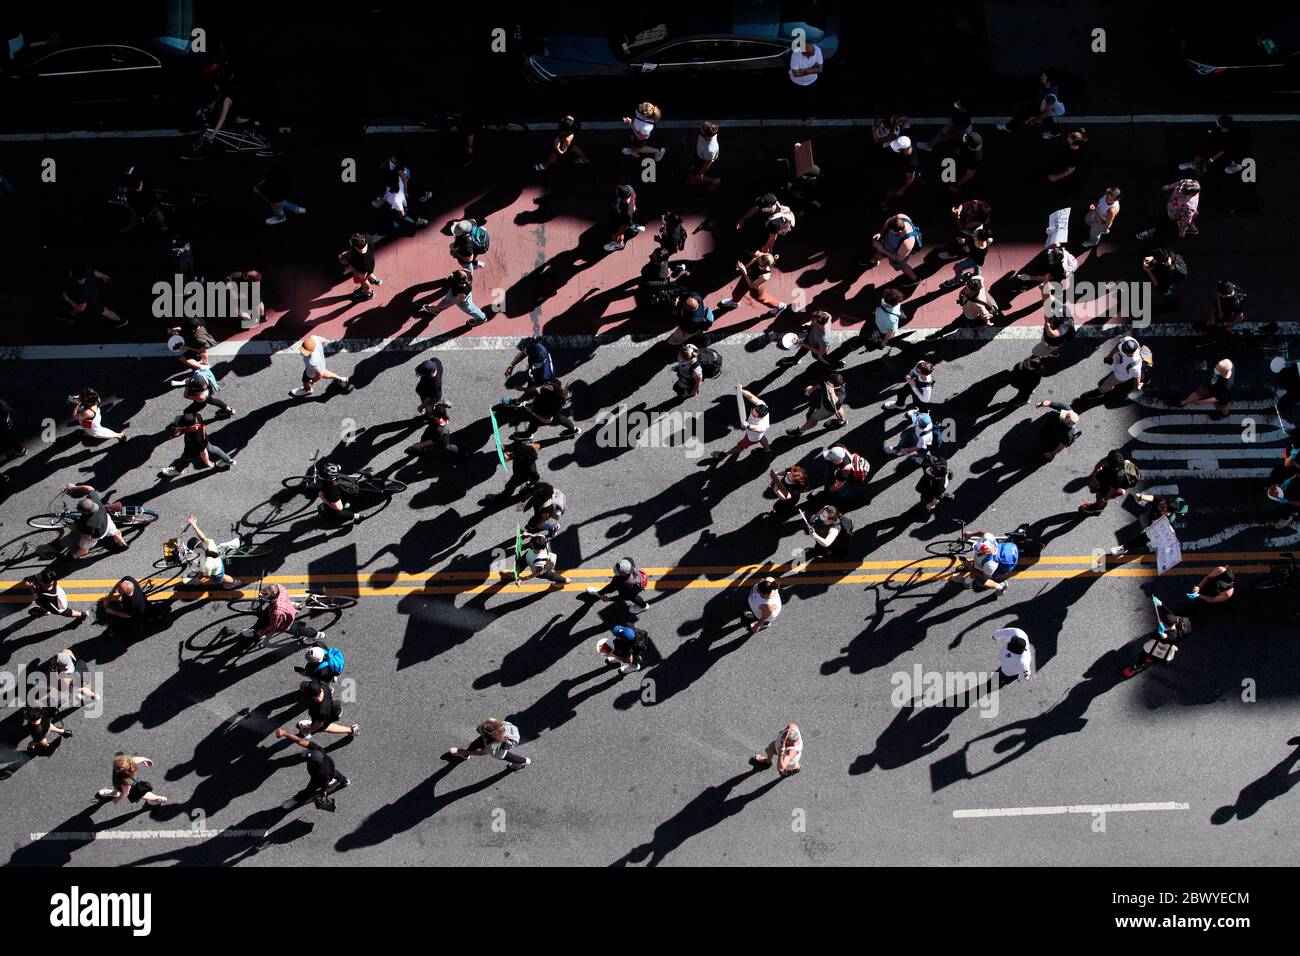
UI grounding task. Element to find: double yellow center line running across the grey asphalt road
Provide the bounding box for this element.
[0,551,1281,604]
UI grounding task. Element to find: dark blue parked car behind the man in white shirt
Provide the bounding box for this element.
[517,0,840,83]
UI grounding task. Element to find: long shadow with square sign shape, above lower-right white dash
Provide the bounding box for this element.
[930,642,1131,792]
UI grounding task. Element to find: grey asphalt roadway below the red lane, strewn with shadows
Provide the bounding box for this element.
[0,329,1300,865]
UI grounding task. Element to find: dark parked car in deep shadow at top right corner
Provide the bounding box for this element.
[1173,12,1300,90]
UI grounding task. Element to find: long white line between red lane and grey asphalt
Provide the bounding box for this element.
[0,323,1300,361]
